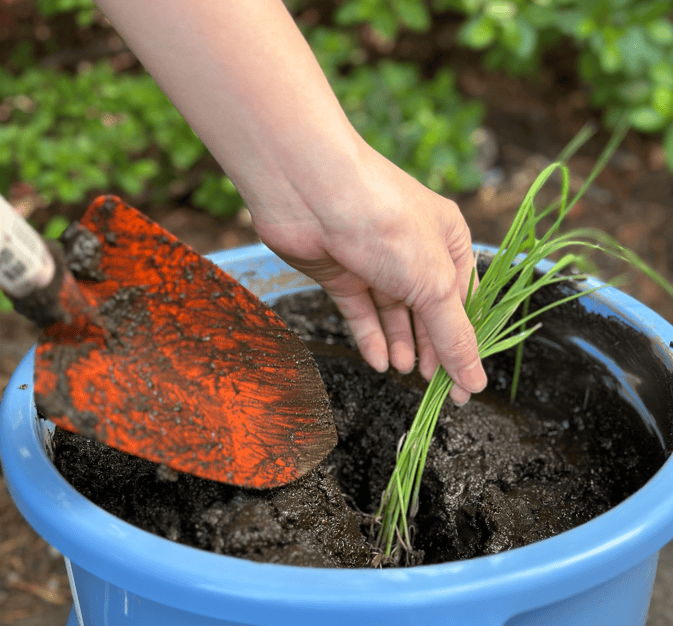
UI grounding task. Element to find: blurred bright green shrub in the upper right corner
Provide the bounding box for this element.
[335,0,673,171]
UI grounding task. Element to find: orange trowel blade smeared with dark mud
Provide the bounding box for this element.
[35,196,336,488]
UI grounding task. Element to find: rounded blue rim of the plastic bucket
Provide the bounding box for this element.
[0,244,673,623]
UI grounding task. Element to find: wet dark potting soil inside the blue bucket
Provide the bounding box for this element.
[54,282,673,567]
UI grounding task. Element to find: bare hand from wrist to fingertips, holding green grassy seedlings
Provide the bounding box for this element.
[253,147,486,404]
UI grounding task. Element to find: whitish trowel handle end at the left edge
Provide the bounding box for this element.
[0,196,55,298]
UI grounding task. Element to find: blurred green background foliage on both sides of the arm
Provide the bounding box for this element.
[0,0,673,217]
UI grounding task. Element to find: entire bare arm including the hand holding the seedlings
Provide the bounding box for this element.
[92,0,486,403]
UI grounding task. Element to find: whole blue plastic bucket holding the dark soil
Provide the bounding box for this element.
[0,240,673,626]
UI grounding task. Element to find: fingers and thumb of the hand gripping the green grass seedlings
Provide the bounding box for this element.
[322,216,487,405]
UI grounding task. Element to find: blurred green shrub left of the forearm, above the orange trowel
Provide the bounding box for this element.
[0,62,241,214]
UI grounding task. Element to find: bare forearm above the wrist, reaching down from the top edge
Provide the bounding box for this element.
[97,0,363,220]
